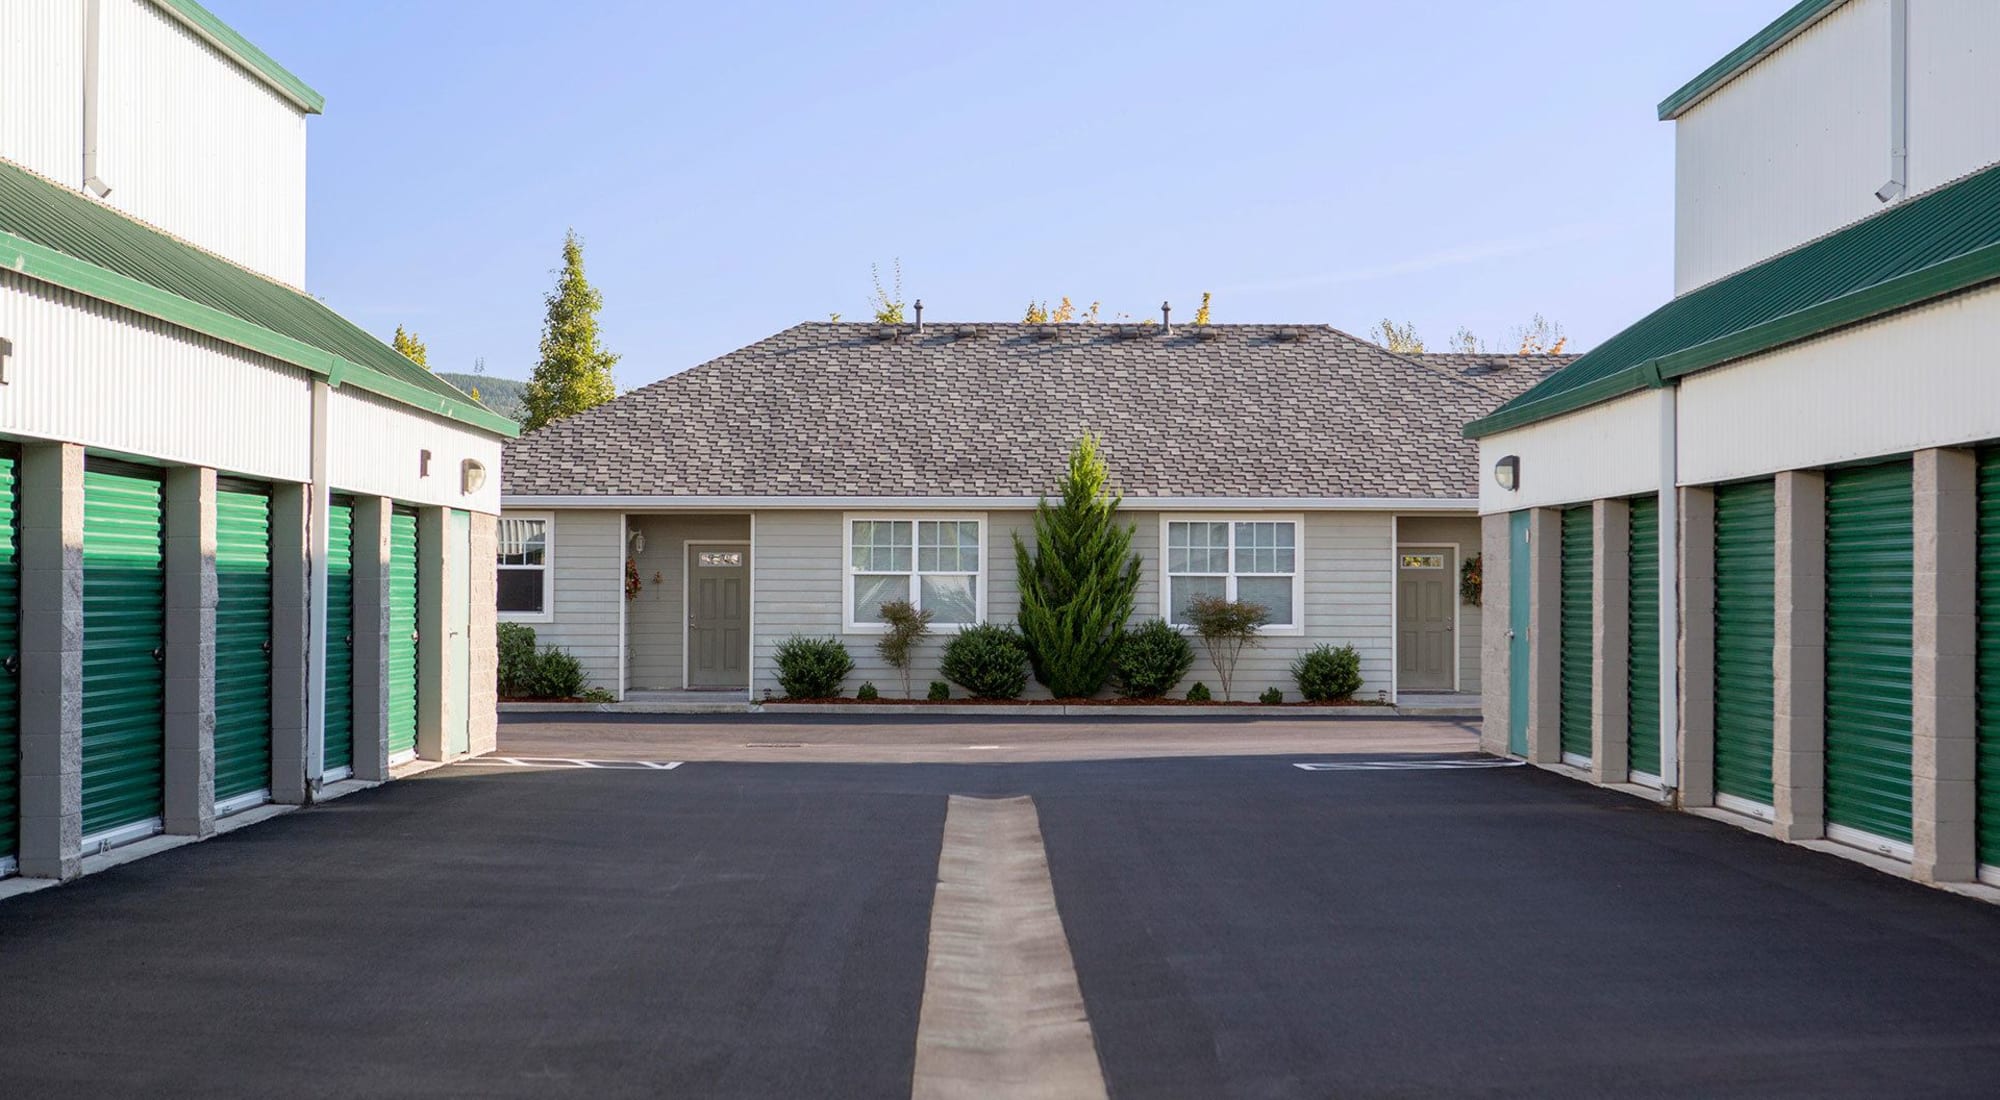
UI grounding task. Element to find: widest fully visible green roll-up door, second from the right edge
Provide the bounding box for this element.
[1826,462,1916,842]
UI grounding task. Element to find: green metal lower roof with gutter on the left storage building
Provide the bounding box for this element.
[0,160,520,436]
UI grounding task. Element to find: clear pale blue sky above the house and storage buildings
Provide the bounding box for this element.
[230,0,1786,388]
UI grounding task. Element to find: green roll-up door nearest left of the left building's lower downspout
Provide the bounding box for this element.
[216,488,270,802]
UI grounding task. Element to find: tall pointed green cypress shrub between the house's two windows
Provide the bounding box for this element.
[1014,436,1140,698]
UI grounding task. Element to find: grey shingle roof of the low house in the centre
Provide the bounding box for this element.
[502,322,1568,498]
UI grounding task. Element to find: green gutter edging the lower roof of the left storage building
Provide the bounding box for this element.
[0,230,520,438]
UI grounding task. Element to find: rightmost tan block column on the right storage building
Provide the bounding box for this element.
[1910,450,1978,882]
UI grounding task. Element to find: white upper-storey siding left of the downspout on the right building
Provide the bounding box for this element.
[1674,0,1888,294]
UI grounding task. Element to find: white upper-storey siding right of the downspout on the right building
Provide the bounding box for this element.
[1910,0,2000,192]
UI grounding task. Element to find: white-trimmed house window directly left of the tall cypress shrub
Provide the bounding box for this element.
[842,516,986,634]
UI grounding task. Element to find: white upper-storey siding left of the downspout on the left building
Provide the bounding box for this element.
[0,0,84,188]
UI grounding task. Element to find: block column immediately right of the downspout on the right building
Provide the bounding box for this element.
[1662,486,1716,806]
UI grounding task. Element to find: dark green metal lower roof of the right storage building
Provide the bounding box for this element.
[1466,168,2000,438]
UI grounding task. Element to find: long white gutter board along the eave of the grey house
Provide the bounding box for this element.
[500,494,1480,514]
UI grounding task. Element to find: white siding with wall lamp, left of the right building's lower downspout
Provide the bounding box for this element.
[1480,392,1666,514]
